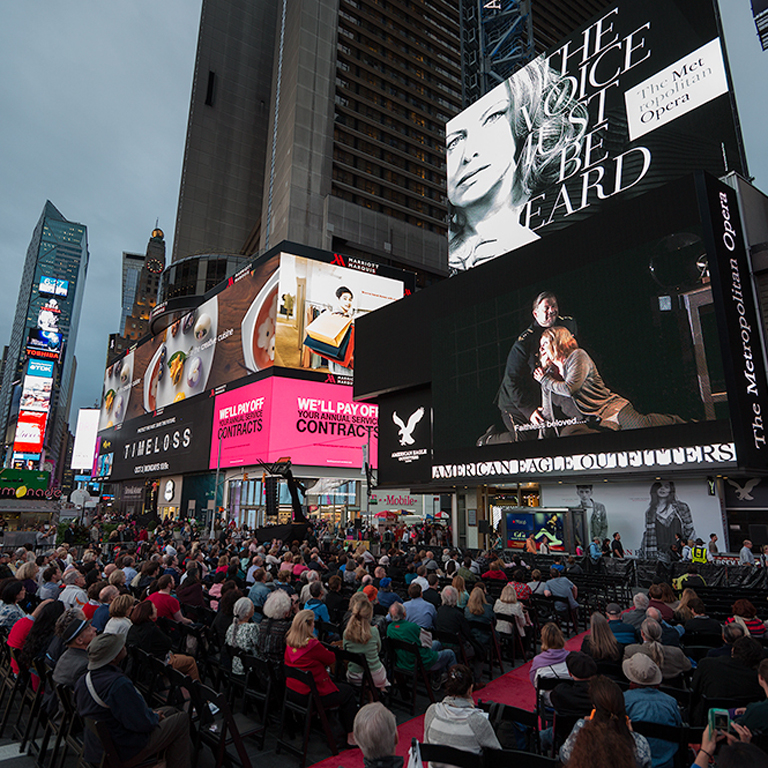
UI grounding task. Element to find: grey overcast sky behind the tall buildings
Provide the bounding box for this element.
[0,0,768,428]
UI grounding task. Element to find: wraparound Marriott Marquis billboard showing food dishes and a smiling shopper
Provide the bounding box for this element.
[99,247,412,430]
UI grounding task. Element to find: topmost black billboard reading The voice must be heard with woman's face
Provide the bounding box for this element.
[446,0,746,270]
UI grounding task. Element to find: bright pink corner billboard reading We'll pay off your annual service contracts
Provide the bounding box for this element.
[210,376,378,469]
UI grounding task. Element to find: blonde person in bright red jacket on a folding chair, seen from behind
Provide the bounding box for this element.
[285,611,357,747]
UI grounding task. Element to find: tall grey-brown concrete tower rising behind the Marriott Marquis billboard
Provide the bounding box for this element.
[173,0,461,274]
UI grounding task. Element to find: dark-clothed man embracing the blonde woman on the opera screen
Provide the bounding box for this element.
[477,291,576,446]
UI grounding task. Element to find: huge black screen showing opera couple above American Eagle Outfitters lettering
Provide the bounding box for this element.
[362,175,768,484]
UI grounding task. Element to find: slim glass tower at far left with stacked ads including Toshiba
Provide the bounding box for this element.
[0,201,88,474]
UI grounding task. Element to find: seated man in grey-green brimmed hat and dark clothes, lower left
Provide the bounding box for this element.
[75,633,191,768]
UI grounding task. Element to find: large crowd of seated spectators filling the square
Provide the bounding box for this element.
[0,533,768,768]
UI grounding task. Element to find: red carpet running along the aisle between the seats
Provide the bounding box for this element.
[311,632,586,768]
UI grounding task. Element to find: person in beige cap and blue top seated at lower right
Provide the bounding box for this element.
[621,653,682,768]
